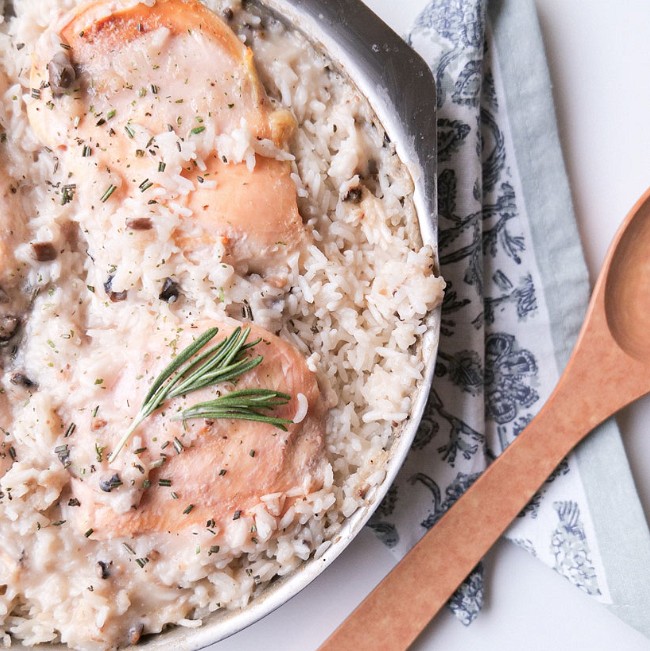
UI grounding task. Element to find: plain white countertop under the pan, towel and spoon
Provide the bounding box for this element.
[210,0,650,651]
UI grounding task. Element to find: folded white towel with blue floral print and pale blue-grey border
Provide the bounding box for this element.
[370,0,650,636]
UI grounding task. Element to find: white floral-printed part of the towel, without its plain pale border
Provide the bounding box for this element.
[370,0,600,624]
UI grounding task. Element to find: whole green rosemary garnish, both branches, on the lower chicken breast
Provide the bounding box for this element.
[108,327,291,463]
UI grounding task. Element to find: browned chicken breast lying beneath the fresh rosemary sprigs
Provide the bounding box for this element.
[70,323,326,539]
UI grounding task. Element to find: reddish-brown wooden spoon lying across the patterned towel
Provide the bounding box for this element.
[320,190,650,651]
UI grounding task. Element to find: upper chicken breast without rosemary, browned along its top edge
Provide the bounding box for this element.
[28,0,304,272]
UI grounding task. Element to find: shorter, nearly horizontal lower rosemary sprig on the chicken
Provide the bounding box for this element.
[173,389,292,432]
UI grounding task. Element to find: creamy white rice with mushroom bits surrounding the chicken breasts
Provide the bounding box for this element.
[0,0,443,649]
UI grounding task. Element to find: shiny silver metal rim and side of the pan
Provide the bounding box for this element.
[11,0,440,651]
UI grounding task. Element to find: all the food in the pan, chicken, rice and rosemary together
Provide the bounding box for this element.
[0,0,443,649]
